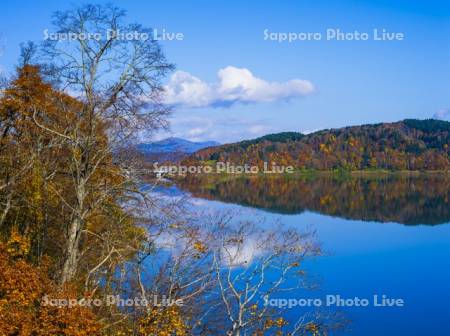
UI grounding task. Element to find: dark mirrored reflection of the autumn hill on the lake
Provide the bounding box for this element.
[179,175,450,225]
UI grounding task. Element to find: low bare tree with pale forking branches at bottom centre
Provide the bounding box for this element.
[205,215,320,336]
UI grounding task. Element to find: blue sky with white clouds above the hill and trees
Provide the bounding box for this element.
[0,0,450,143]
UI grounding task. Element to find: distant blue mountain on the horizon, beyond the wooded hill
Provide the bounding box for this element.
[137,138,220,160]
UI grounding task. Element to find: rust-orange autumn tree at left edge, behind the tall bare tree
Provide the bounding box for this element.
[0,66,74,258]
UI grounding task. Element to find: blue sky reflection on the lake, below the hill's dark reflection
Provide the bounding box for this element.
[156,186,450,336]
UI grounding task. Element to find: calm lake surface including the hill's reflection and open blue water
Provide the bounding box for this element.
[158,174,450,336]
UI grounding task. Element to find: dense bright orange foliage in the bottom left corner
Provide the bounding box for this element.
[0,242,101,336]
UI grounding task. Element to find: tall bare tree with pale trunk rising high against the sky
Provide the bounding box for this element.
[26,5,173,283]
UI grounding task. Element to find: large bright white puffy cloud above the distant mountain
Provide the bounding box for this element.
[165,66,314,107]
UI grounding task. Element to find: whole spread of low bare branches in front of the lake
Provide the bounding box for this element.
[134,212,324,336]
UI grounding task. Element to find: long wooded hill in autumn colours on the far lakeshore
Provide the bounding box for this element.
[185,119,450,170]
